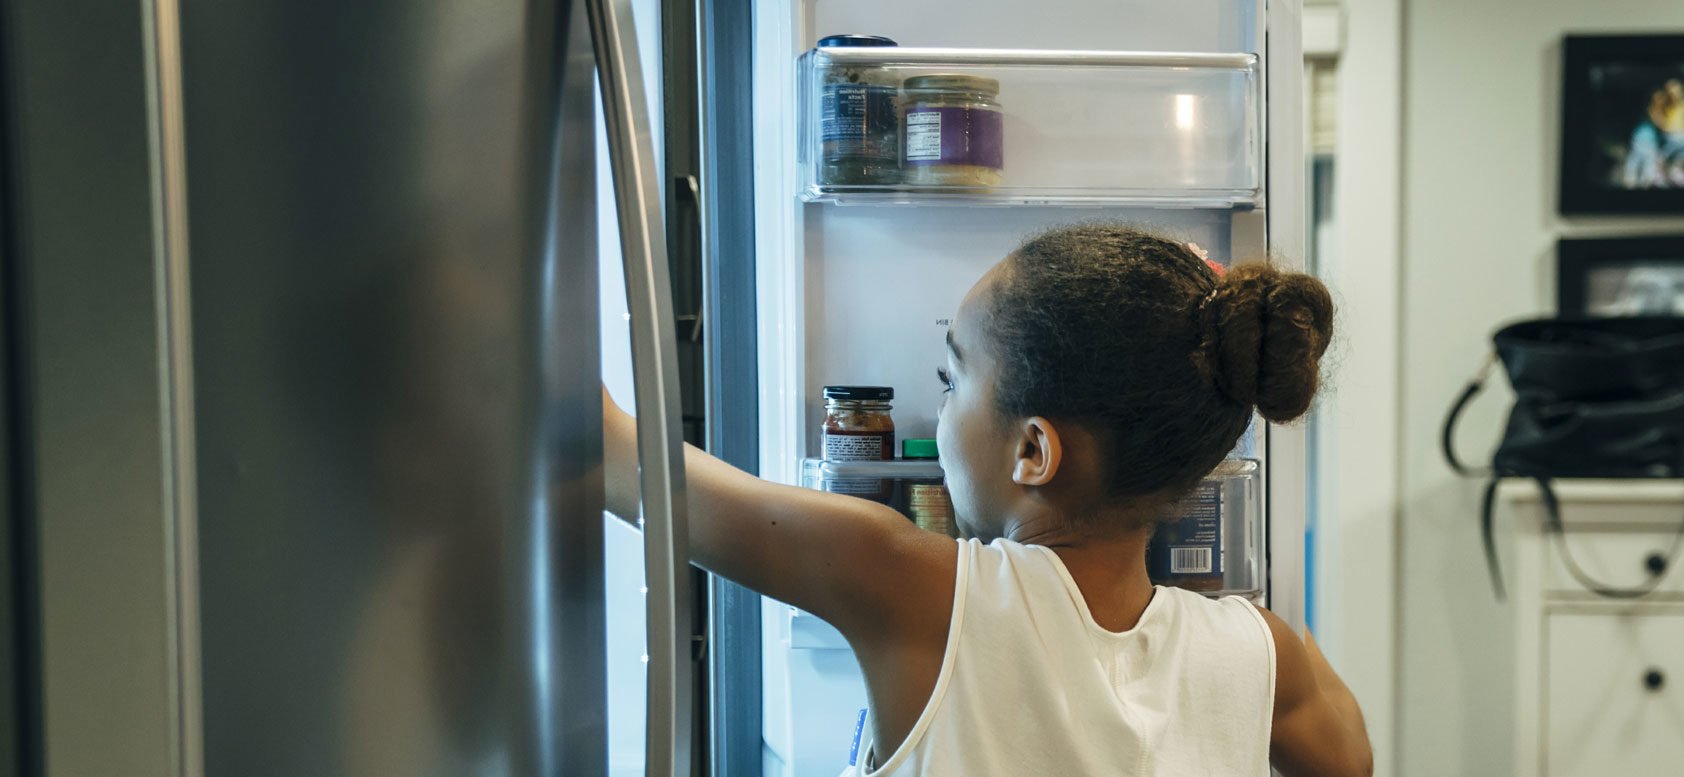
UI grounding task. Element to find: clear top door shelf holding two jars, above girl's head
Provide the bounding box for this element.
[797,47,1263,209]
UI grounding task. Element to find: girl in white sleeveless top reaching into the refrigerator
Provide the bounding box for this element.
[605,226,1372,777]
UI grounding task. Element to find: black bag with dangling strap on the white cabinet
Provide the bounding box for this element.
[1442,317,1684,598]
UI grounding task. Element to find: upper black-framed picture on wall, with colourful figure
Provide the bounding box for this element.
[1561,34,1684,214]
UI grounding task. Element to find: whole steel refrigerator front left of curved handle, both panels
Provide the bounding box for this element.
[5,0,605,775]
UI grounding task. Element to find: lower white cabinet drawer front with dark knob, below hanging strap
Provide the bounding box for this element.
[1544,614,1684,777]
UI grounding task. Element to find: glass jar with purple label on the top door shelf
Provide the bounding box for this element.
[901,74,1005,187]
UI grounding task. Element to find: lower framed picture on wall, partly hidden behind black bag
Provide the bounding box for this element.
[1556,234,1684,317]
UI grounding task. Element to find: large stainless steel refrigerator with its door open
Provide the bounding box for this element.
[0,0,1308,777]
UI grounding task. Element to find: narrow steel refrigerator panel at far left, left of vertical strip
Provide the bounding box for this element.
[0,0,197,777]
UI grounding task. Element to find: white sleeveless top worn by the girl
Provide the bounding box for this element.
[844,539,1275,777]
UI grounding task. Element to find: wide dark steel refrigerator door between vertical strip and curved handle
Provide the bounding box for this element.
[182,0,605,775]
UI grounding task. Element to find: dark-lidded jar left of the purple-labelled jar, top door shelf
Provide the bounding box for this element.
[818,35,901,185]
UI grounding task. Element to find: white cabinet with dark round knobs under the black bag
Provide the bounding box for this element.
[1504,480,1684,777]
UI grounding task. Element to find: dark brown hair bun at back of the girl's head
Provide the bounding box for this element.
[1194,261,1334,423]
